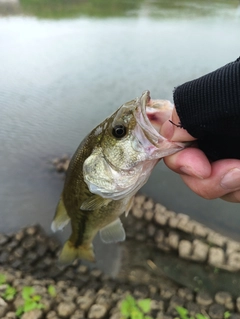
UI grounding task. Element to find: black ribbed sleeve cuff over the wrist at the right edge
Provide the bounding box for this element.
[173,58,240,160]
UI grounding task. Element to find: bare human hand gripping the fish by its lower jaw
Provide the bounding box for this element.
[161,108,240,203]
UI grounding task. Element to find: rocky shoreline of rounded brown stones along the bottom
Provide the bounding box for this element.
[0,195,240,319]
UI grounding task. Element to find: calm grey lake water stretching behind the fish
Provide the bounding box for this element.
[0,0,240,270]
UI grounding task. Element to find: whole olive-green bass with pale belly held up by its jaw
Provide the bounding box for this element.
[51,91,186,265]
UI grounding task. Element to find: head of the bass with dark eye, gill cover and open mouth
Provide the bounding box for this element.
[83,91,187,200]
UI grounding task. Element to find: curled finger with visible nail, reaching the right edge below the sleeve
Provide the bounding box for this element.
[181,159,240,199]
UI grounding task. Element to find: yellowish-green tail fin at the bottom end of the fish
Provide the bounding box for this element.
[59,240,95,265]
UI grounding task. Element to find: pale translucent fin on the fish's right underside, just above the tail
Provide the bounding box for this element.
[100,218,126,244]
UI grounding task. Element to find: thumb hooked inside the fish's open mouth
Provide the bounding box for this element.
[160,107,195,142]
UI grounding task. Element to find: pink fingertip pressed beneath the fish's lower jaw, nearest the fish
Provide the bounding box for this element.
[164,147,211,179]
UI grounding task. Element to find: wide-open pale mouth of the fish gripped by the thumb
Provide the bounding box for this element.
[134,91,187,157]
